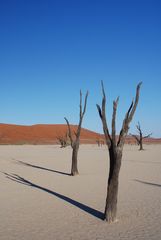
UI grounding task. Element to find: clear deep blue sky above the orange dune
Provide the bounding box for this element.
[0,0,161,137]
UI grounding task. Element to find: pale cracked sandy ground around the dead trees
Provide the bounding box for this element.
[0,145,161,240]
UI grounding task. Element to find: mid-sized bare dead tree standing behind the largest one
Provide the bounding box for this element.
[65,91,88,176]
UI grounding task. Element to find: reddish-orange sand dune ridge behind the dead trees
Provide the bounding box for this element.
[0,123,161,144]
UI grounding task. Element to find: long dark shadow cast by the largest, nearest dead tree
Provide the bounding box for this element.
[3,172,104,220]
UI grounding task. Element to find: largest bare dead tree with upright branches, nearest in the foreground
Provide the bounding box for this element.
[97,81,141,223]
